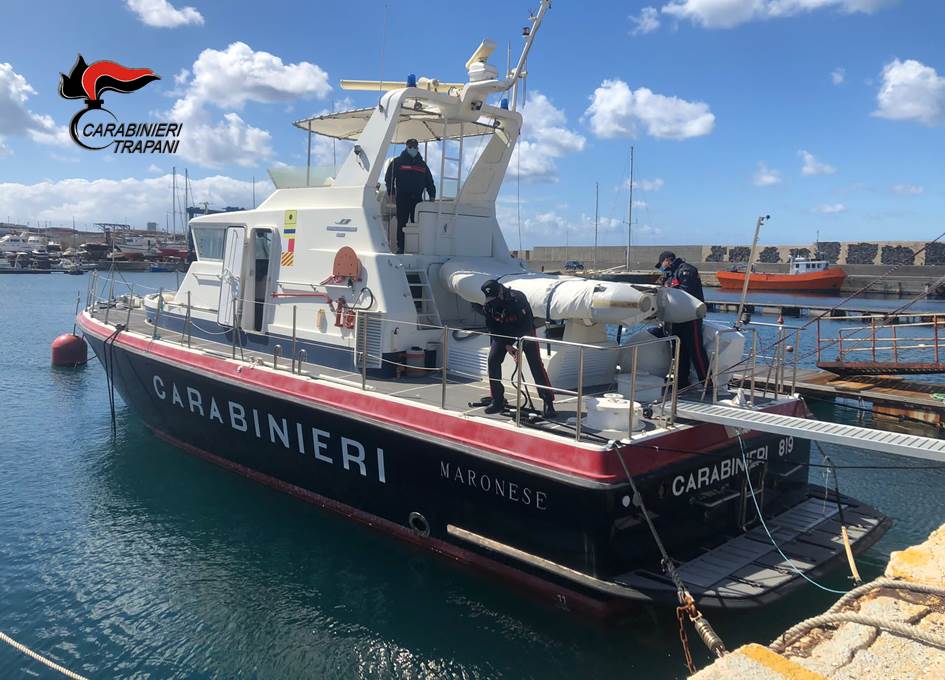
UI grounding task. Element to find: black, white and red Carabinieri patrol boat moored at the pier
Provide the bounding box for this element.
[78,0,888,615]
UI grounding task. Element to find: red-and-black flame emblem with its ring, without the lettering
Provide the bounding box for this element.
[59,54,161,151]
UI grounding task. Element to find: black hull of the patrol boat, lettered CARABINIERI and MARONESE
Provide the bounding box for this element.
[86,318,881,615]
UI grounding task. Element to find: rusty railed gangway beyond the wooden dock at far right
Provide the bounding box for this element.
[817,312,945,376]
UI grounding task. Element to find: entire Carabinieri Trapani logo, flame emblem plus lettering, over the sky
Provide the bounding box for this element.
[59,54,184,153]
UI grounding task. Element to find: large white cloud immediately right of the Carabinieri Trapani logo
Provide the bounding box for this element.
[166,42,331,167]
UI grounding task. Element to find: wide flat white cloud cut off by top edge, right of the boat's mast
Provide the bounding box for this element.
[661,0,897,28]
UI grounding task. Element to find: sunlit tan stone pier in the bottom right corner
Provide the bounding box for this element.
[692,525,945,680]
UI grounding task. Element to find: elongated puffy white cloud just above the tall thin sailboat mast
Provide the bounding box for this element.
[584,80,715,139]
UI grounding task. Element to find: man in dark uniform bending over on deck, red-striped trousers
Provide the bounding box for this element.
[482,279,557,418]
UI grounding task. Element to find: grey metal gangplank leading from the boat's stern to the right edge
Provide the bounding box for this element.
[676,400,945,463]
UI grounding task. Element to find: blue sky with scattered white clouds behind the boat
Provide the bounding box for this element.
[0,0,945,247]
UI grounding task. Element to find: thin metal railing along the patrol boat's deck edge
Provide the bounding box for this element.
[86,277,799,442]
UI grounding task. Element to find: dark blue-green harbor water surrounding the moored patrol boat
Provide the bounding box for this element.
[0,274,945,678]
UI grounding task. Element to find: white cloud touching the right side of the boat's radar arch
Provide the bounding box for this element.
[508,91,586,181]
